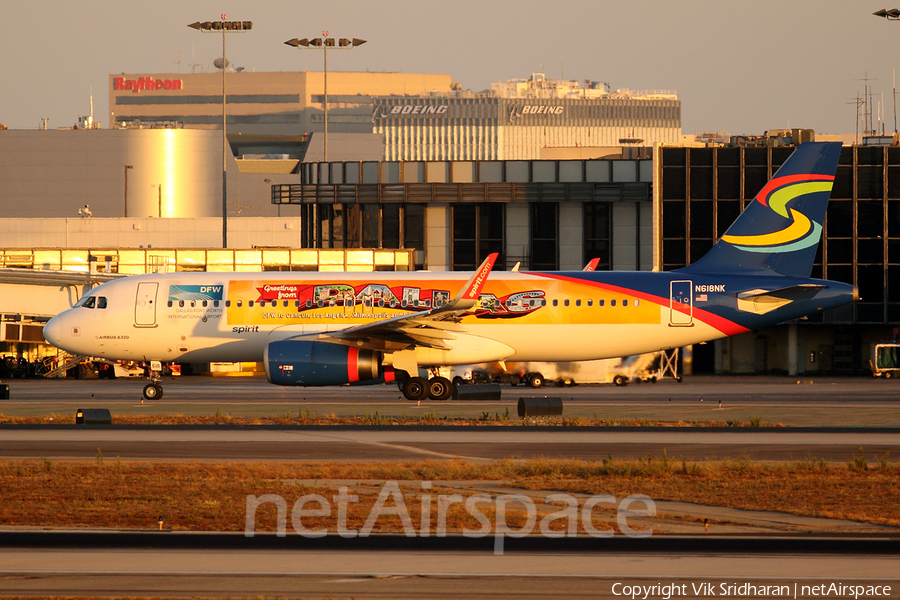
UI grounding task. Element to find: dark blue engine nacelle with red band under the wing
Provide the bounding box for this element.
[263,340,382,386]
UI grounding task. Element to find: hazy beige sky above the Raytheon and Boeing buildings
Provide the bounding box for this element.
[0,0,900,134]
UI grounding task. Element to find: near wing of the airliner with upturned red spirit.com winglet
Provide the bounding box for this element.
[302,253,497,351]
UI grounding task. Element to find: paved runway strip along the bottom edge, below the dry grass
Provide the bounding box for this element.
[0,534,900,598]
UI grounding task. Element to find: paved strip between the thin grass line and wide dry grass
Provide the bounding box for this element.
[0,425,900,462]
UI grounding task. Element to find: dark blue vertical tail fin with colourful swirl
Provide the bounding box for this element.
[680,142,841,277]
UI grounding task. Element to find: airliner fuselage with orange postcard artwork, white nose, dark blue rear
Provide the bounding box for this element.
[45,271,854,366]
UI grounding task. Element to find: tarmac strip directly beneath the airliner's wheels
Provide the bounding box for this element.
[0,376,900,427]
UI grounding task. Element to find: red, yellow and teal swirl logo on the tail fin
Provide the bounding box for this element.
[722,174,834,253]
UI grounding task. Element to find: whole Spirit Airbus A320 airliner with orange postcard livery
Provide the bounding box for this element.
[44,143,858,400]
